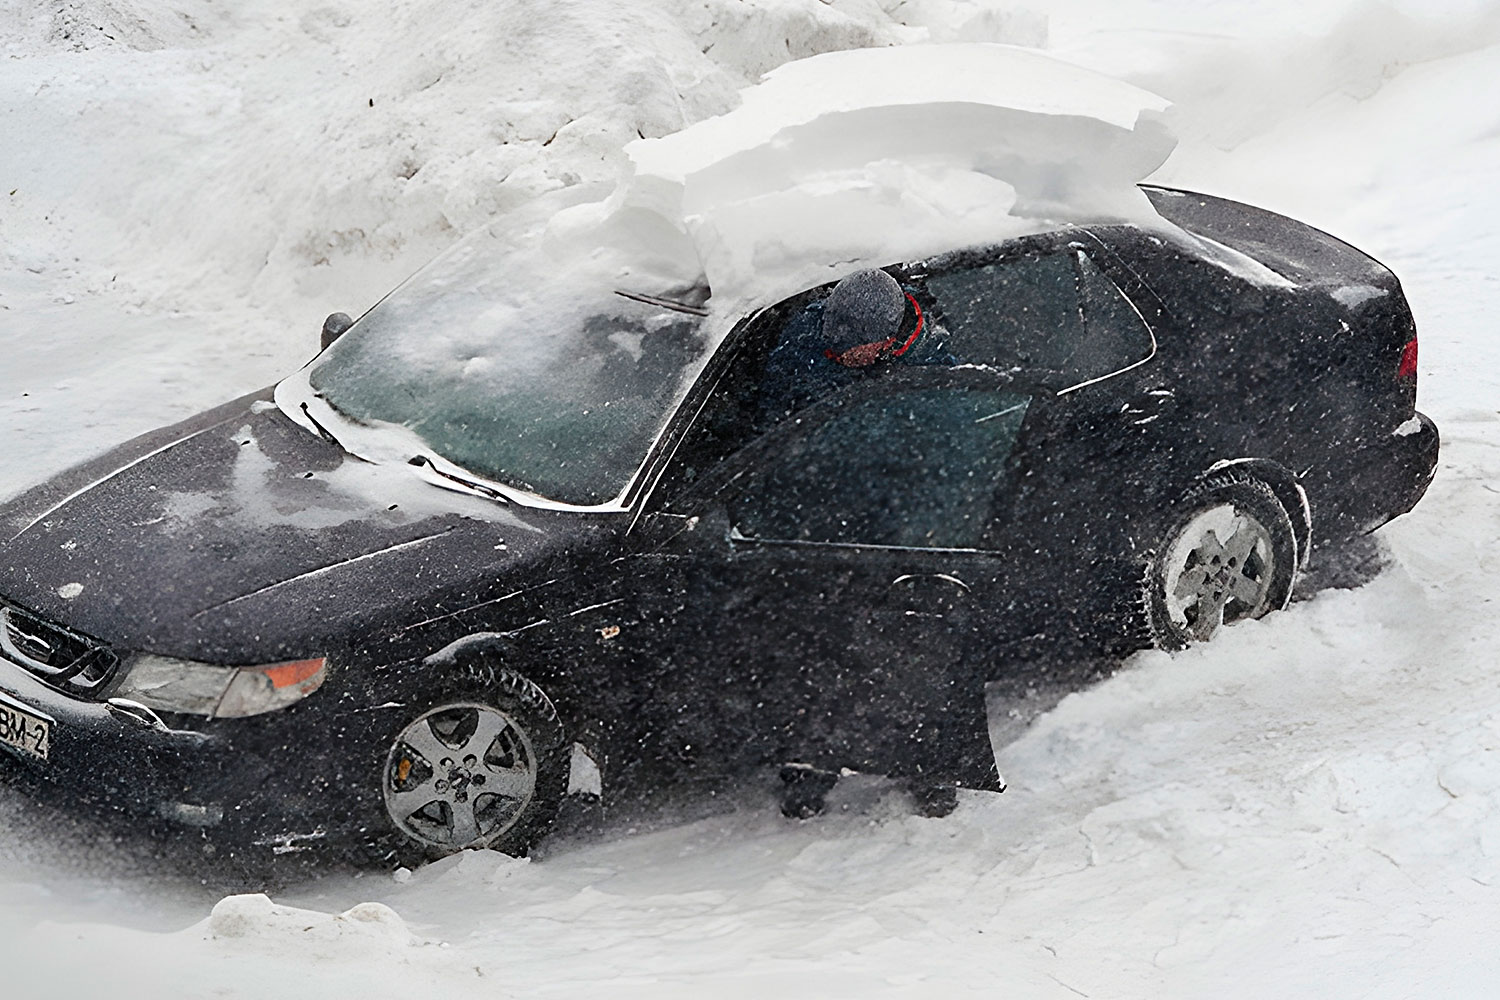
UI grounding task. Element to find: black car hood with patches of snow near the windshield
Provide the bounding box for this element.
[0,394,600,663]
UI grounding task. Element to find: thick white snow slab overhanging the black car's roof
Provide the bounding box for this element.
[626,43,1175,301]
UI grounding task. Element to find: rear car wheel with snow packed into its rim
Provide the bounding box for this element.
[1142,472,1298,649]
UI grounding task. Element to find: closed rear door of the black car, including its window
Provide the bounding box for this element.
[906,232,1175,641]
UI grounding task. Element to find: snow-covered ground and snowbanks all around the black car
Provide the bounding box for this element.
[0,0,1500,997]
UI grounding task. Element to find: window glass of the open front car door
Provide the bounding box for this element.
[728,388,1029,549]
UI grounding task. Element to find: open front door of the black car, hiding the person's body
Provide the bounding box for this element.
[627,289,1031,786]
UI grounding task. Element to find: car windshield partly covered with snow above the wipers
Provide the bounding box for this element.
[309,199,714,505]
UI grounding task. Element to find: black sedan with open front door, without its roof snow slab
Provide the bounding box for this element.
[0,189,1437,858]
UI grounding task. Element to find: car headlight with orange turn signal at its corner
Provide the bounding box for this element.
[113,654,326,718]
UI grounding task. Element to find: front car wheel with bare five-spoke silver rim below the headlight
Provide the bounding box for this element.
[362,664,572,867]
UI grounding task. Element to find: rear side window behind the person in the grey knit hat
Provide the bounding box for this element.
[927,249,1152,390]
